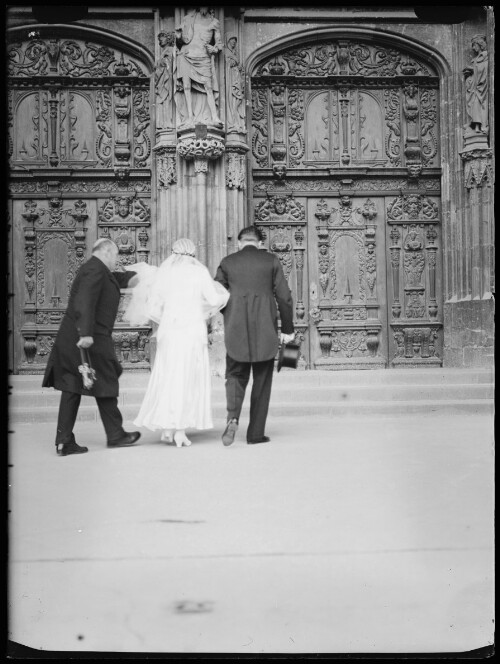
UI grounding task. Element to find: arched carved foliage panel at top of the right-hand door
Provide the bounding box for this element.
[256,39,437,77]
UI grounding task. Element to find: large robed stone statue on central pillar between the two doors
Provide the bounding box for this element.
[174,7,222,127]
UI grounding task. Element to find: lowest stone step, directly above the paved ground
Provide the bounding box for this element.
[9,399,493,422]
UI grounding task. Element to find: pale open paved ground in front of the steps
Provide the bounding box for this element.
[9,415,494,653]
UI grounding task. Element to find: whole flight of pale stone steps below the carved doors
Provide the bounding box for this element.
[9,369,494,423]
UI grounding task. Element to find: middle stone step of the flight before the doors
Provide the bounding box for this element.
[9,380,494,410]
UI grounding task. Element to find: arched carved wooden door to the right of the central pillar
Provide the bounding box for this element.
[251,39,442,369]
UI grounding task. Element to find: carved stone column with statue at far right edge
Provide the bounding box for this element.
[445,27,495,367]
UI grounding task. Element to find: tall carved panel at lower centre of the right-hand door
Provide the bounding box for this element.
[310,195,385,368]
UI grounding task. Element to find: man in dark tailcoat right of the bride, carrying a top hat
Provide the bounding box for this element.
[215,226,294,445]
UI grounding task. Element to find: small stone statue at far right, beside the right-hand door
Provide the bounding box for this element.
[463,35,488,134]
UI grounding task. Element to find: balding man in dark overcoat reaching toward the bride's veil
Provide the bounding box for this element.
[42,238,141,456]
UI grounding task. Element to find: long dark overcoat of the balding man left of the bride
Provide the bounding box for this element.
[42,256,135,397]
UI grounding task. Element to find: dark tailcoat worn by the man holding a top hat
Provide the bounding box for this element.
[215,245,294,362]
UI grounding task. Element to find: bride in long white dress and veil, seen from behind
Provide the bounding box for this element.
[124,238,229,447]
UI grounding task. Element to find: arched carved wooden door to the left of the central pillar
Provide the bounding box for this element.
[8,27,151,373]
